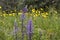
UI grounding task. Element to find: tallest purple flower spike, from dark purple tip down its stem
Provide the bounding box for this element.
[21,6,27,40]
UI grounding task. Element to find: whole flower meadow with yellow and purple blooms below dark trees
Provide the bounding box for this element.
[0,9,60,40]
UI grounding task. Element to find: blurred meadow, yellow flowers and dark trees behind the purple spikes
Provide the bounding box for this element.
[0,0,60,40]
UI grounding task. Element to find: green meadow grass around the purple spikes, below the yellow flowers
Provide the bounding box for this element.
[0,9,60,40]
